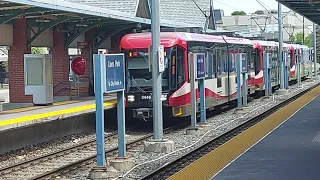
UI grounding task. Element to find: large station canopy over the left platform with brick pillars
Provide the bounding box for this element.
[0,0,199,47]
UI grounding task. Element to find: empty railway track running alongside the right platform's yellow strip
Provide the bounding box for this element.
[142,84,319,179]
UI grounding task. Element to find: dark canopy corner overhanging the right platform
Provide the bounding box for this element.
[277,0,320,25]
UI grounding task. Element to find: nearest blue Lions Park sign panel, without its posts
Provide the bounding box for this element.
[103,54,125,93]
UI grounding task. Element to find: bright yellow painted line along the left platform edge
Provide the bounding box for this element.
[0,100,117,126]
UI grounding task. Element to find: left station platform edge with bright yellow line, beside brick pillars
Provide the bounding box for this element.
[0,94,117,131]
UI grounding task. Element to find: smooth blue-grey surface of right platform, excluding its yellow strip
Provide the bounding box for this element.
[212,97,320,180]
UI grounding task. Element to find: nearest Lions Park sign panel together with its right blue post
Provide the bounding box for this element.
[105,54,126,157]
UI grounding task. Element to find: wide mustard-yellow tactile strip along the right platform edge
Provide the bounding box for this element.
[168,86,320,180]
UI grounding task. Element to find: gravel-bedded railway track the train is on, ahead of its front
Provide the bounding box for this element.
[0,123,186,180]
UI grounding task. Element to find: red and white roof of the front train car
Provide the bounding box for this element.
[120,32,252,49]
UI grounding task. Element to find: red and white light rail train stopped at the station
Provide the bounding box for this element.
[121,32,311,120]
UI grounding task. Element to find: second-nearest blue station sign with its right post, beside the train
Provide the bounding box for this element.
[194,53,207,124]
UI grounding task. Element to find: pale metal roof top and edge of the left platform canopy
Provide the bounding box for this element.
[4,0,200,27]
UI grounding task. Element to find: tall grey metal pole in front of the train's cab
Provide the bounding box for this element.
[151,0,163,140]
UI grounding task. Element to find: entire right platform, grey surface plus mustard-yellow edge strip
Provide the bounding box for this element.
[169,86,320,180]
